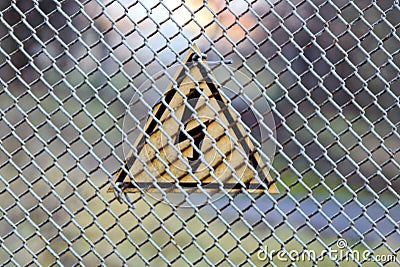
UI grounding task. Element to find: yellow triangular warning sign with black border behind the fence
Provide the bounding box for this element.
[109,47,278,196]
